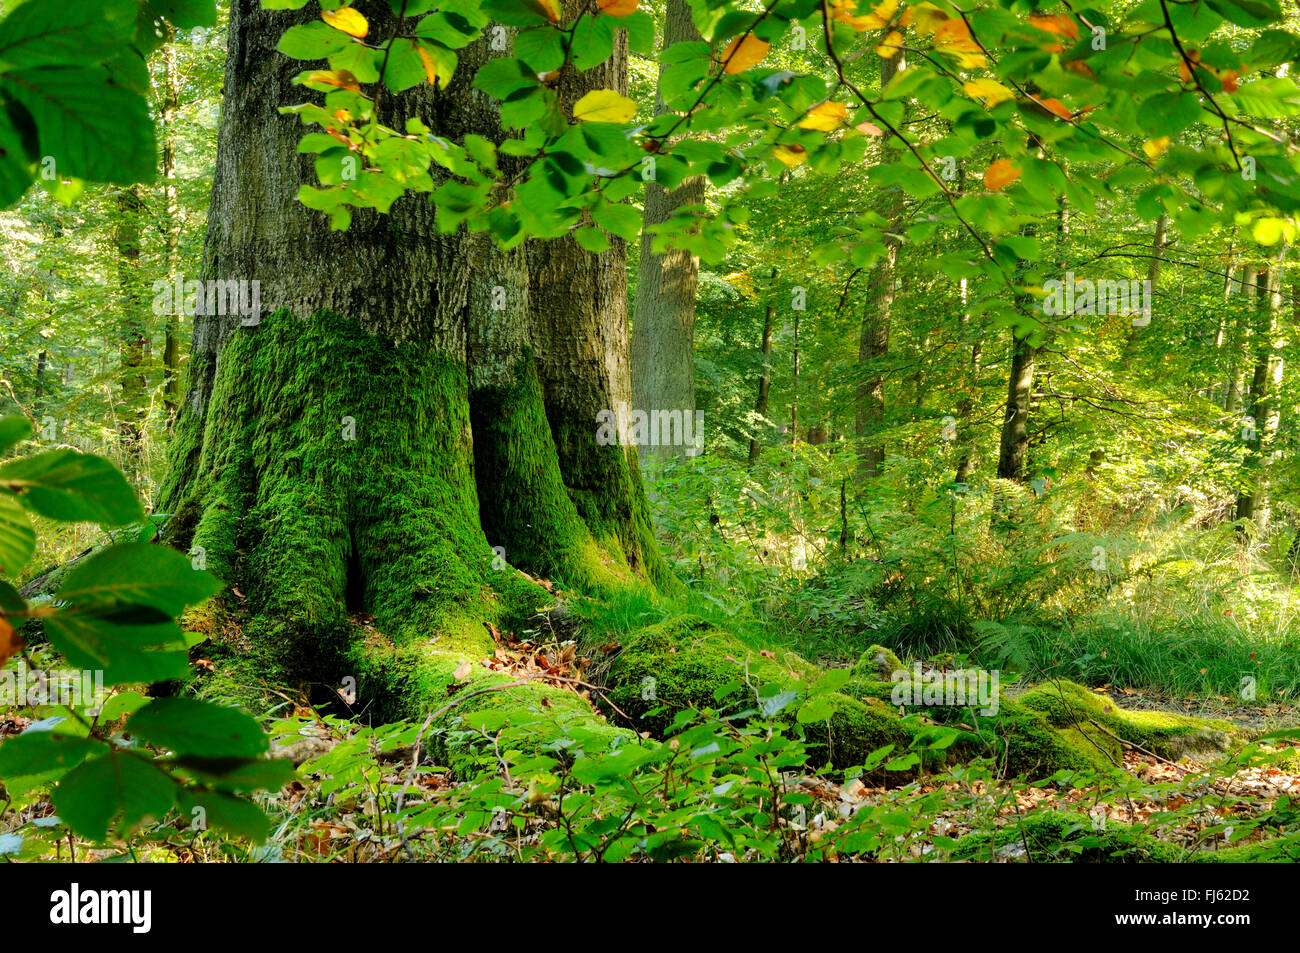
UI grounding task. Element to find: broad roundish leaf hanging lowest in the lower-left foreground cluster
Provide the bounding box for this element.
[53,749,177,841]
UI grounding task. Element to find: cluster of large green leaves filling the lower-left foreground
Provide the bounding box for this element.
[0,408,286,841]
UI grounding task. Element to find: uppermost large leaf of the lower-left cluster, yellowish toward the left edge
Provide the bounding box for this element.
[0,450,144,527]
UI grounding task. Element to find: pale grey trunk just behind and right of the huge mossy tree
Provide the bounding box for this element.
[632,0,705,471]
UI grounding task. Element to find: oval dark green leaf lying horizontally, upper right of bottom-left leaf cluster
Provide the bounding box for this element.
[126,697,269,758]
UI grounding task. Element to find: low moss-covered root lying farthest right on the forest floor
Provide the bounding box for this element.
[1017,681,1235,761]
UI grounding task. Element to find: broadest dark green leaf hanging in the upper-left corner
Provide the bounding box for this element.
[0,66,157,185]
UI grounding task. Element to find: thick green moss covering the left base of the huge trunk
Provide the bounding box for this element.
[164,312,631,764]
